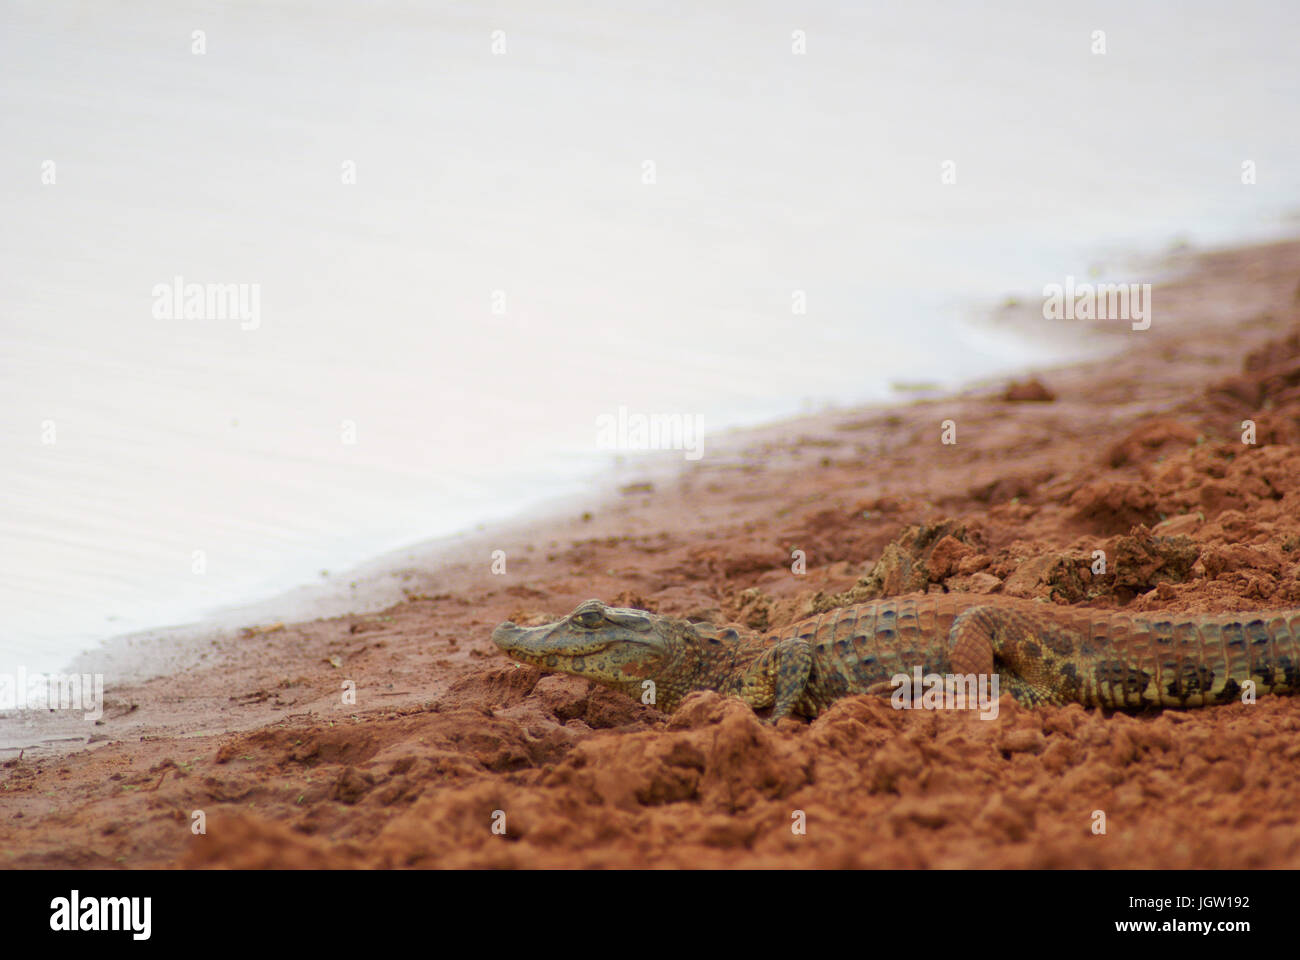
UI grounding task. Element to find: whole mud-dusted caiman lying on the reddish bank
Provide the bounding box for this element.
[493,593,1300,722]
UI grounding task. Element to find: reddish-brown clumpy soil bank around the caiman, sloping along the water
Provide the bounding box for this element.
[0,243,1300,868]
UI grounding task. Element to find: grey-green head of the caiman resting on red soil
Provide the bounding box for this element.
[491,600,699,710]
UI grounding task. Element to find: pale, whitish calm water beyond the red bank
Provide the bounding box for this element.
[0,1,1300,671]
